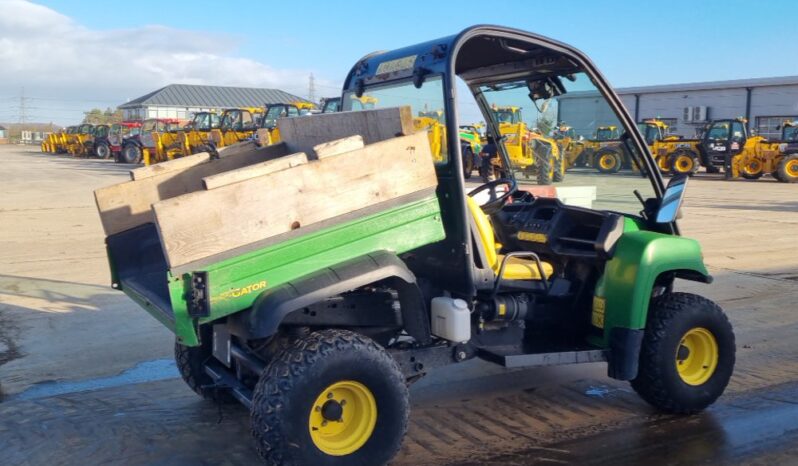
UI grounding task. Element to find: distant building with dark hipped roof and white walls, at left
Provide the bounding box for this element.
[119,84,307,120]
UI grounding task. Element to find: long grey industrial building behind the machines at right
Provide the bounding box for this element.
[557,76,798,138]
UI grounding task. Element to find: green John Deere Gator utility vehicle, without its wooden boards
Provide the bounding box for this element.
[107,26,735,465]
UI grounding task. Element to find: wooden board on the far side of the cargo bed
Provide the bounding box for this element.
[94,144,288,236]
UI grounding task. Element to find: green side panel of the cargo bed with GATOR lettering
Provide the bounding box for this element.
[109,195,445,346]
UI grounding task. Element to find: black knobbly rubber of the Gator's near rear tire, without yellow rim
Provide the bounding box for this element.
[250,329,409,466]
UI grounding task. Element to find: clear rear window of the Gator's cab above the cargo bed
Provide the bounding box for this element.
[342,76,448,164]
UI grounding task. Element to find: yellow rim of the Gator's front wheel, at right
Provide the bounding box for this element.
[676,327,718,386]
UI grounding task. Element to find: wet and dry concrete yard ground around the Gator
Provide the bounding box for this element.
[0,146,798,465]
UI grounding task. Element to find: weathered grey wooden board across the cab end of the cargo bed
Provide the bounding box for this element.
[277,106,415,159]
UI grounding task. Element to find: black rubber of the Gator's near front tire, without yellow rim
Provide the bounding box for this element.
[631,292,735,414]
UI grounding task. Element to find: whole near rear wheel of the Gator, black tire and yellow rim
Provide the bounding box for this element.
[250,329,410,466]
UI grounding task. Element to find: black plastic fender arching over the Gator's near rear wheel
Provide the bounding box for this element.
[228,251,431,343]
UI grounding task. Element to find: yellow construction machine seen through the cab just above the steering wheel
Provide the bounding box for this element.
[489,106,566,185]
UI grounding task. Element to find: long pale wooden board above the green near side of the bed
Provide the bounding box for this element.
[153,131,437,267]
